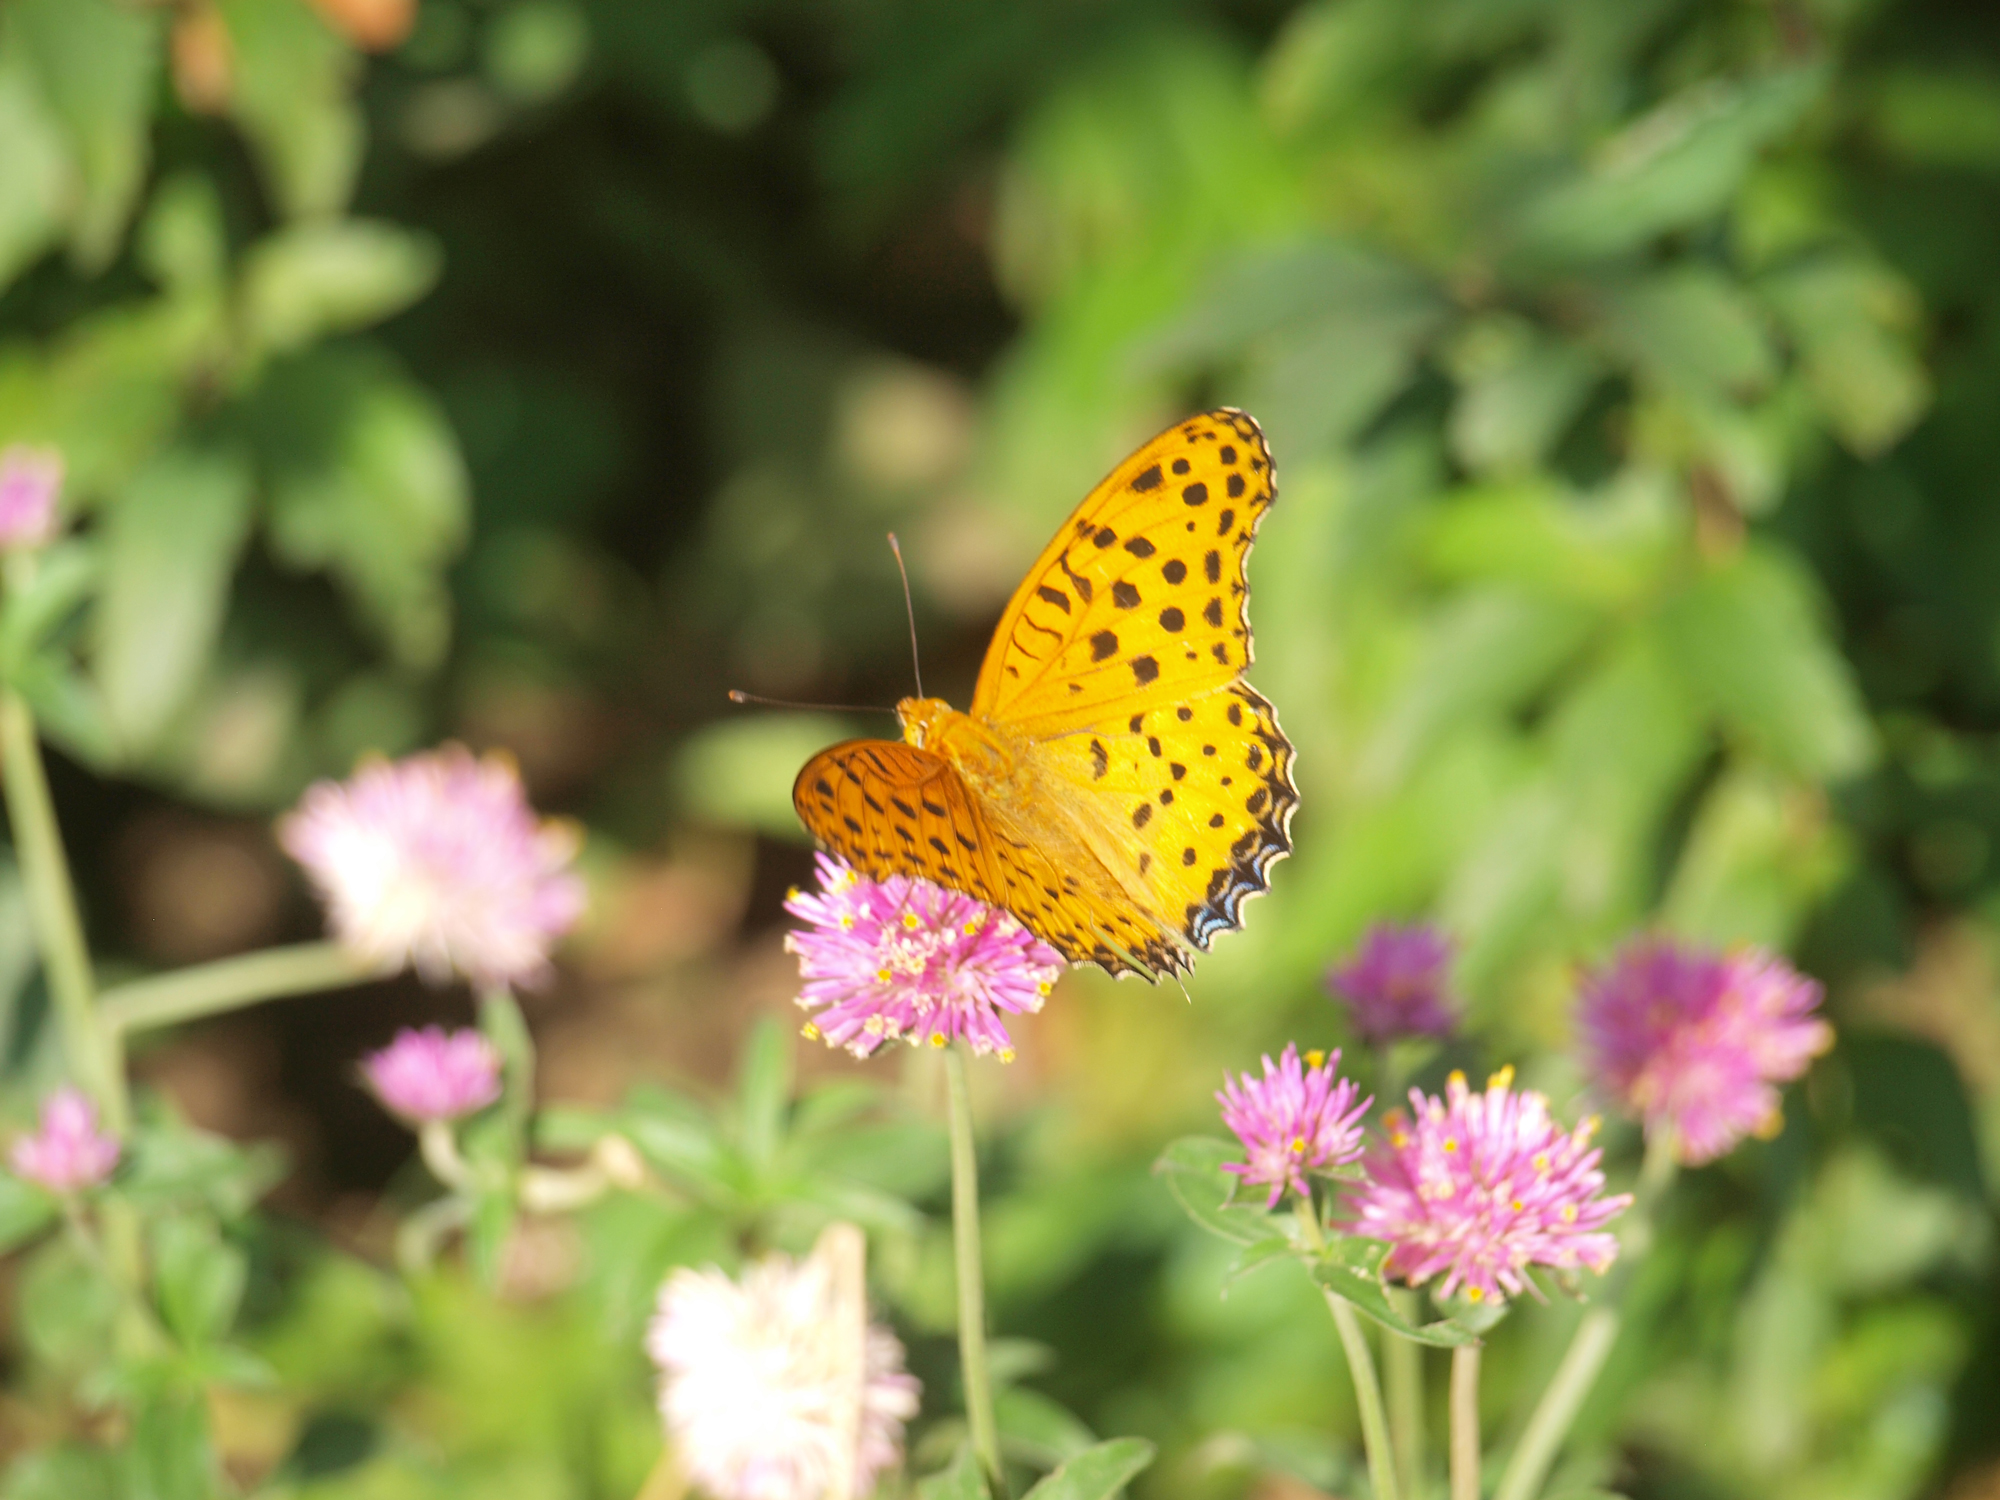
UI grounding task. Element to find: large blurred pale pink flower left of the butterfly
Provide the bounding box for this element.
[278,744,584,984]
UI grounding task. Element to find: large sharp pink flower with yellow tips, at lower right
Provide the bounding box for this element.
[1346,1068,1632,1302]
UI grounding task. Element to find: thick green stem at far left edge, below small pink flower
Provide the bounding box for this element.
[0,688,111,1134]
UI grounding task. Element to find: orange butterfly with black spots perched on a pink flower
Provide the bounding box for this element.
[792,408,1298,980]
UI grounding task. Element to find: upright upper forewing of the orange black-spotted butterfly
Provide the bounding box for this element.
[972,408,1274,736]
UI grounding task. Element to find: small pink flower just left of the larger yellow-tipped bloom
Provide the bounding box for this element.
[1216,1046,1374,1208]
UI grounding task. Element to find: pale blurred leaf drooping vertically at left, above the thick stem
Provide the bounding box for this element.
[96,448,250,752]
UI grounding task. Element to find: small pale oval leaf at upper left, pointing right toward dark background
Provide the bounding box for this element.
[242,218,442,354]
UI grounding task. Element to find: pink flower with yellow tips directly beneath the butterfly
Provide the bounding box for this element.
[784,854,1062,1062]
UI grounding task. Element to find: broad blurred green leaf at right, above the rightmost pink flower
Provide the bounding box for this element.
[1660,546,1876,782]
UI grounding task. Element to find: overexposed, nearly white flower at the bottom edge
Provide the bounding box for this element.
[646,1256,920,1500]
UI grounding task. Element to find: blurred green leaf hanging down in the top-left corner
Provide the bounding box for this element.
[8,0,164,274]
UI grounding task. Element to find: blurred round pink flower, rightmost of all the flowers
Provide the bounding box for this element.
[1576,938,1834,1166]
